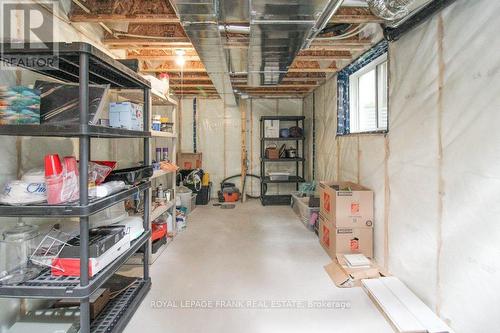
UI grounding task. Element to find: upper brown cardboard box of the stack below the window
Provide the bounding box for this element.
[319,182,373,228]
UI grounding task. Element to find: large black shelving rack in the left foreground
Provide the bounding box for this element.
[0,43,151,333]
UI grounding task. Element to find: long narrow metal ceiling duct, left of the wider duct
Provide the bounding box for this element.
[174,0,237,105]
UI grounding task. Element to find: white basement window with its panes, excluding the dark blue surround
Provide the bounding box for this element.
[349,53,387,133]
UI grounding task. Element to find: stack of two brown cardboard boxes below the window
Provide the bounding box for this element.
[319,182,373,260]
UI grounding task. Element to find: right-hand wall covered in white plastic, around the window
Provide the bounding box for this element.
[304,0,500,333]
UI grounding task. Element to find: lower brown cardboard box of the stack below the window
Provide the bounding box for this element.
[319,215,373,259]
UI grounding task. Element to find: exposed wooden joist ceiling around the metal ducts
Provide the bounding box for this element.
[69,0,381,98]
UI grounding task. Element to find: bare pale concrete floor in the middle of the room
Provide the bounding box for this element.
[125,201,393,333]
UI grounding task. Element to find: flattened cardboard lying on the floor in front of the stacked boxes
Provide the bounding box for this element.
[324,254,386,288]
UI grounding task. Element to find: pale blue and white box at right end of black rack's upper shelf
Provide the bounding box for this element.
[109,102,144,131]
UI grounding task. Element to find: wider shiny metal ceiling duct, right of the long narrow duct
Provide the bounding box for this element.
[248,0,343,86]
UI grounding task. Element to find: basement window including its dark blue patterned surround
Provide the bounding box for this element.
[337,41,388,135]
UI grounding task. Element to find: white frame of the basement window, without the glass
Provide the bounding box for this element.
[348,52,389,134]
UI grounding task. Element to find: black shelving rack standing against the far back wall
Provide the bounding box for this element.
[260,116,306,206]
